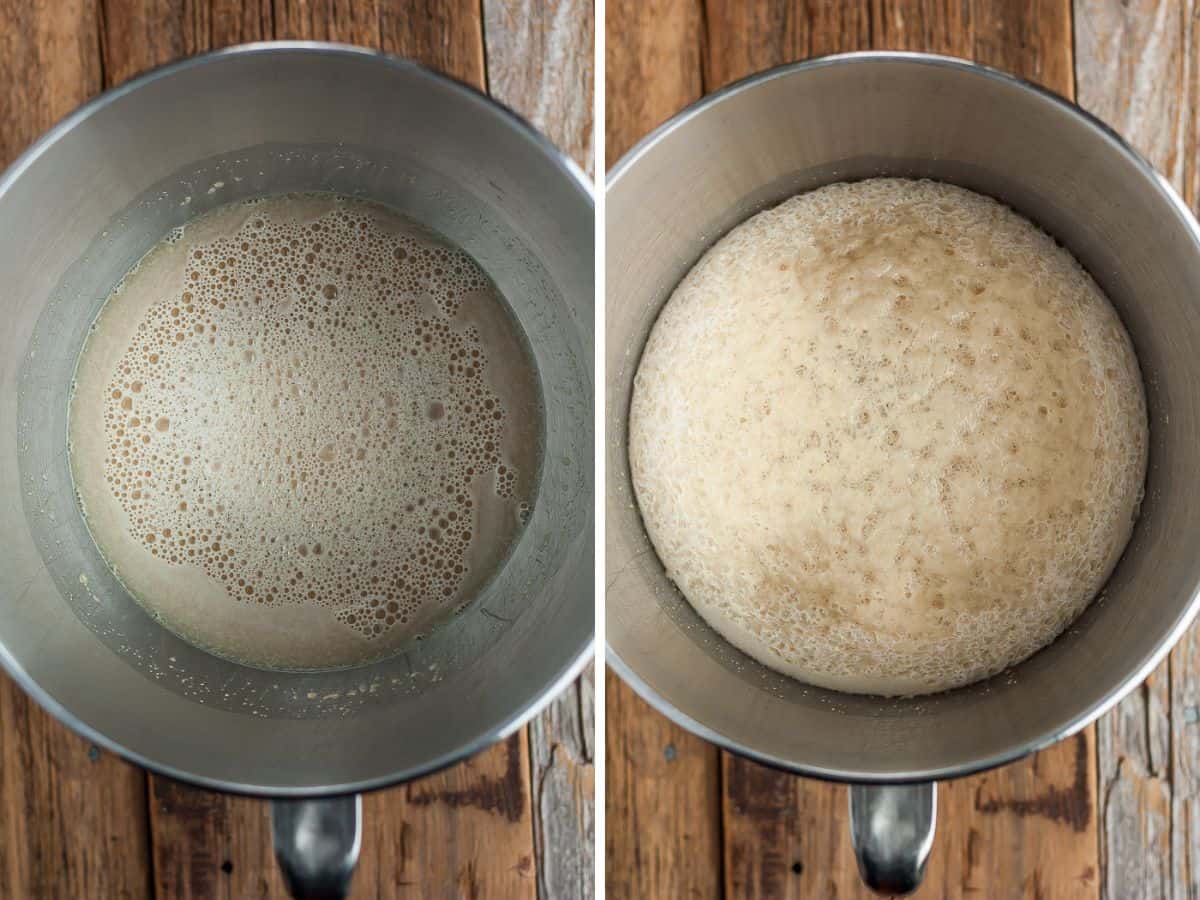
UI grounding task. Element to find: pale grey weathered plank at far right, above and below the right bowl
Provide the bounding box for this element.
[1075,0,1200,900]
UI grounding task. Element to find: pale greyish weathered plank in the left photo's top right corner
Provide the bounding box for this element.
[484,0,595,174]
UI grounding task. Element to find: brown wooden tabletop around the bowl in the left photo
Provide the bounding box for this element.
[0,0,594,900]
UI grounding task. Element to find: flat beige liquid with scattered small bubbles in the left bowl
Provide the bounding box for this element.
[70,196,541,668]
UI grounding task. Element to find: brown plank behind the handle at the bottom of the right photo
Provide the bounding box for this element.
[724,734,1099,900]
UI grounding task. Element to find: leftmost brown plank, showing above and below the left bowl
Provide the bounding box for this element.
[0,0,151,898]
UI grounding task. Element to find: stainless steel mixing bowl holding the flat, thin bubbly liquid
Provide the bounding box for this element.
[0,43,594,897]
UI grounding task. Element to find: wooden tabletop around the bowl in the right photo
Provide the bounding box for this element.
[606,0,1200,900]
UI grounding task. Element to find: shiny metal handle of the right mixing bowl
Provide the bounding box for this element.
[850,781,937,894]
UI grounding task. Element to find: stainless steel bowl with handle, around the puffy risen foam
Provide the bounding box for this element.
[606,53,1200,890]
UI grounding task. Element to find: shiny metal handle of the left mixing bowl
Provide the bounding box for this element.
[271,794,362,900]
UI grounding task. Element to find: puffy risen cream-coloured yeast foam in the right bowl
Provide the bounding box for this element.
[630,179,1147,695]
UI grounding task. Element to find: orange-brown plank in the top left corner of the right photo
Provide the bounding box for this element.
[605,0,704,166]
